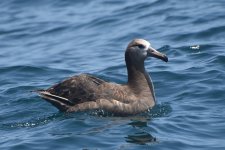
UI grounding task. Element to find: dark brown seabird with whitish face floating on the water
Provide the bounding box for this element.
[37,39,168,116]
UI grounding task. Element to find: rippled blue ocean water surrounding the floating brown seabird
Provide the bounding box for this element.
[0,0,225,150]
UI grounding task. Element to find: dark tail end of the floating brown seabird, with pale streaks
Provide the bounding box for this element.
[32,90,74,111]
